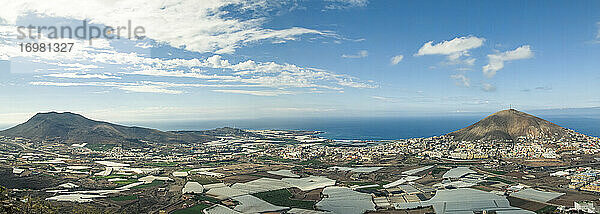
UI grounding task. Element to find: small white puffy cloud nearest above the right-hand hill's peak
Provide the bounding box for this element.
[483,45,533,78]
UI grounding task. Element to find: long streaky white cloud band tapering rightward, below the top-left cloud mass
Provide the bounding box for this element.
[0,29,371,93]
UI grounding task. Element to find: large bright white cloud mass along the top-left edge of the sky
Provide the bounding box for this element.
[0,0,331,53]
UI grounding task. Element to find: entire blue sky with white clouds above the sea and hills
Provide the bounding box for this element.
[0,0,600,123]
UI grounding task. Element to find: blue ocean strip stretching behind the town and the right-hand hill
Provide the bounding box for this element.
[126,115,600,140]
